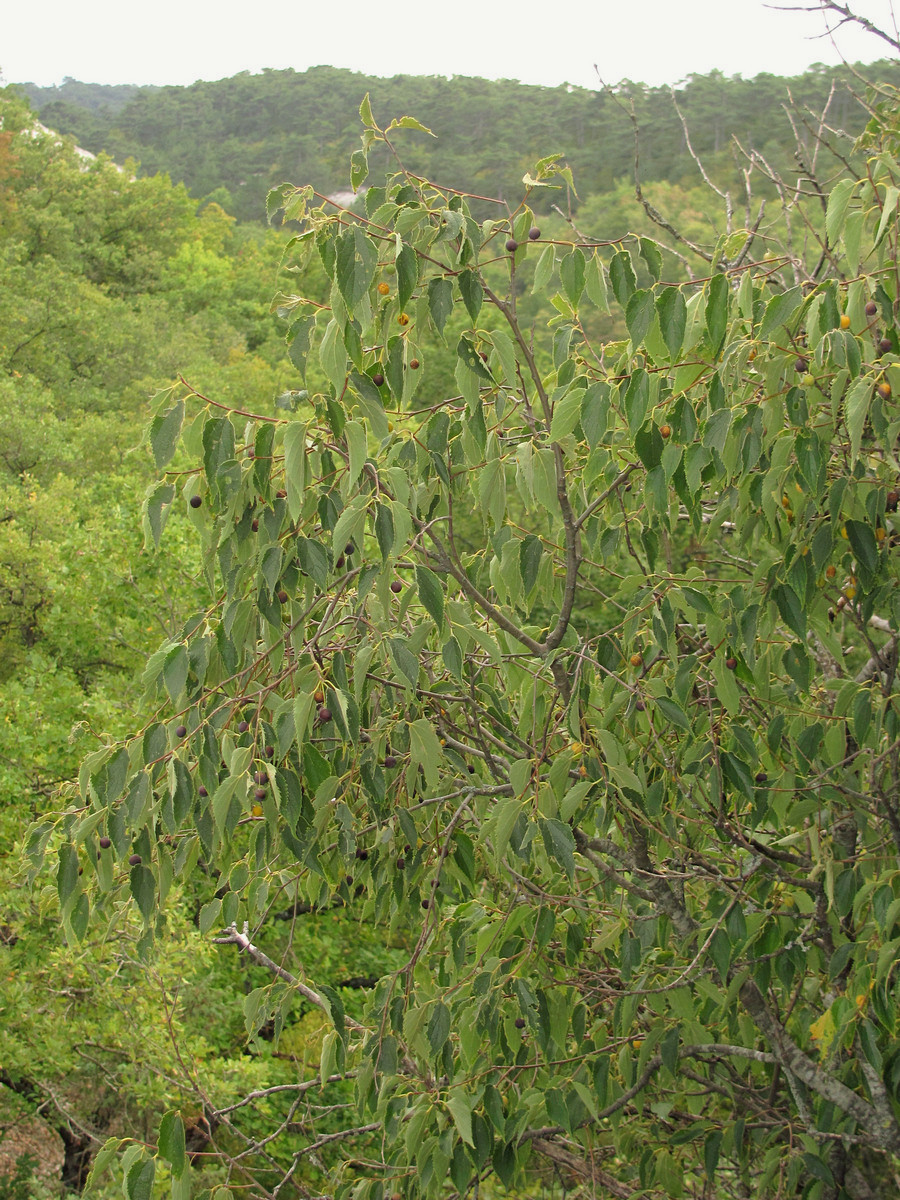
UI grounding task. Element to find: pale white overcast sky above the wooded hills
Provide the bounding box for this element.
[0,0,900,88]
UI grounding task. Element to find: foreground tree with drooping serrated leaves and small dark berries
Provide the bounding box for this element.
[37,84,900,1200]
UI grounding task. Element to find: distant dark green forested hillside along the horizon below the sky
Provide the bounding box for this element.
[15,61,900,221]
